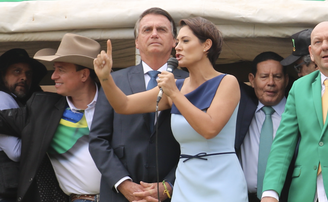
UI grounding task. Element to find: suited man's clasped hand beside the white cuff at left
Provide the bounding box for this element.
[117,180,144,202]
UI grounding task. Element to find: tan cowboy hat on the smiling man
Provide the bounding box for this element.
[34,33,100,69]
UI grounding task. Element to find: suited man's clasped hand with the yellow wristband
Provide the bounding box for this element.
[134,182,172,202]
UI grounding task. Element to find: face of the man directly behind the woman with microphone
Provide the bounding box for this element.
[135,14,175,56]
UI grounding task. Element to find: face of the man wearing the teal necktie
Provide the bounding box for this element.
[248,60,288,106]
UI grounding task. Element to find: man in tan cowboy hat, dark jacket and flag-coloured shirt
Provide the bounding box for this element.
[0,34,101,202]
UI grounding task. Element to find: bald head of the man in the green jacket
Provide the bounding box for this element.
[309,21,328,77]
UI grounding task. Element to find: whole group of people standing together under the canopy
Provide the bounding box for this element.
[0,7,328,202]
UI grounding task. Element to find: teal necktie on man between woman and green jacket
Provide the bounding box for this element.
[257,106,274,199]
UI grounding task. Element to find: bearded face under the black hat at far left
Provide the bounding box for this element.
[3,63,32,98]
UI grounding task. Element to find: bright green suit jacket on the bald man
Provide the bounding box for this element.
[263,71,328,202]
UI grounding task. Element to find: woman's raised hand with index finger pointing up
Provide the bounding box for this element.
[93,39,113,82]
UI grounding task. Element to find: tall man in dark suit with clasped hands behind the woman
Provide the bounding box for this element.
[90,8,188,202]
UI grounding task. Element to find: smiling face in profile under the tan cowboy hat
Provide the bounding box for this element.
[51,62,84,96]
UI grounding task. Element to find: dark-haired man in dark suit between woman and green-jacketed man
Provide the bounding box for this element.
[235,52,288,202]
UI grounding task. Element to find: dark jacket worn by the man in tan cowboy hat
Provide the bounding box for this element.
[0,92,66,202]
